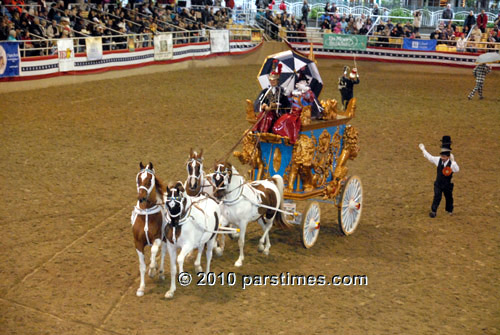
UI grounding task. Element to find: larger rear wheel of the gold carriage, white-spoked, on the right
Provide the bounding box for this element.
[339,176,363,235]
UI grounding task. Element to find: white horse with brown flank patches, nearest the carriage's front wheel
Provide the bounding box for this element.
[213,162,286,267]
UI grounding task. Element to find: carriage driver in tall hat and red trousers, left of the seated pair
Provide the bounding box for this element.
[252,60,290,133]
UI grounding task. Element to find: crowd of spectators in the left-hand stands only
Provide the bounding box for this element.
[0,0,234,56]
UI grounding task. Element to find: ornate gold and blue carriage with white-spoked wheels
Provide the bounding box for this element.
[234,94,363,248]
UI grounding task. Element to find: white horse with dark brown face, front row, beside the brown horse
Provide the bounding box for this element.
[165,182,225,298]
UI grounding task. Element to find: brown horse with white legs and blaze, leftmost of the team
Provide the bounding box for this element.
[131,162,166,297]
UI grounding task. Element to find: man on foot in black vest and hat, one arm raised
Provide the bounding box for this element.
[418,136,459,218]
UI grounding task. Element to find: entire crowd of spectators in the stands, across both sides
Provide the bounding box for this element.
[0,0,500,56]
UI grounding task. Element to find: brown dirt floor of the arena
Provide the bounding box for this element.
[0,45,500,335]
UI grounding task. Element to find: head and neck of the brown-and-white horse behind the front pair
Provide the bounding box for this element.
[184,148,214,197]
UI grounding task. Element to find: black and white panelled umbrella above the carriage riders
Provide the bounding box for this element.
[257,50,323,97]
